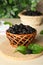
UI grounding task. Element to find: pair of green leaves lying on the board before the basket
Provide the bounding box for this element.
[16,43,43,54]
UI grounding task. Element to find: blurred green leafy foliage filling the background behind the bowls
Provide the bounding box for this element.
[0,0,40,18]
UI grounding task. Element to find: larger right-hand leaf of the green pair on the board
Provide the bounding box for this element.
[28,43,43,54]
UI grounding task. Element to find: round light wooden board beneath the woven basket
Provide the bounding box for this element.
[0,36,43,60]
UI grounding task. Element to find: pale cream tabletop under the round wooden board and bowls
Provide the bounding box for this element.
[0,19,43,65]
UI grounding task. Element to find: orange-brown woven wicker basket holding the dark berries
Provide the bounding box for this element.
[6,31,36,47]
